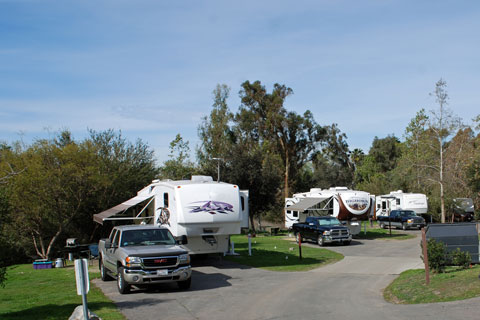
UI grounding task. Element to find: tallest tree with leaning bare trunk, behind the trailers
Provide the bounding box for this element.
[236,81,325,197]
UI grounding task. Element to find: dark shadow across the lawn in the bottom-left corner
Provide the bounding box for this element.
[0,302,112,320]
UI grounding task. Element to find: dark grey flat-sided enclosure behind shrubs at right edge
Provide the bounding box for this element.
[427,223,479,263]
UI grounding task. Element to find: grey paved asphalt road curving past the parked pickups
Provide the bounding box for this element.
[95,231,480,320]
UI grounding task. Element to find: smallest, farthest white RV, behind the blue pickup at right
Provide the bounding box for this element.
[375,190,428,217]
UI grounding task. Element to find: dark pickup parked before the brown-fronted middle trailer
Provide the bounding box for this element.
[292,216,352,246]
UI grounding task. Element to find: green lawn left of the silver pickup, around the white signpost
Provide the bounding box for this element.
[0,264,125,320]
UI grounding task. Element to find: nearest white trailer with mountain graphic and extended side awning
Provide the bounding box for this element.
[93,176,248,254]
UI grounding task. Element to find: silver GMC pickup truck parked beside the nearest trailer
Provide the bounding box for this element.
[98,225,192,294]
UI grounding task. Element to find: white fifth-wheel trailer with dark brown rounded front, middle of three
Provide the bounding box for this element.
[285,187,375,234]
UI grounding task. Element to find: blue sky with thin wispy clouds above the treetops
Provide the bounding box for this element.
[0,0,480,163]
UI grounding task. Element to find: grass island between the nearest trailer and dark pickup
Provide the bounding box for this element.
[225,235,343,271]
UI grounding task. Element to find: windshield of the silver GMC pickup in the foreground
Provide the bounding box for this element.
[120,229,176,247]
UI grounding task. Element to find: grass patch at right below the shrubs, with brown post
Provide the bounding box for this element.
[383,265,480,304]
